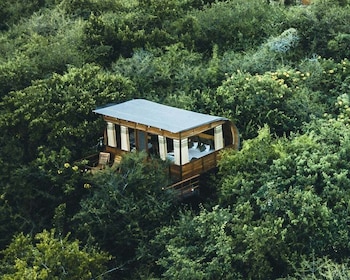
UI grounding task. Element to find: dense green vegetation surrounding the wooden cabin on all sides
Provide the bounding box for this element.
[0,0,350,279]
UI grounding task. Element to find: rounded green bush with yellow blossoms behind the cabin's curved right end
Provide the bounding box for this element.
[197,70,323,139]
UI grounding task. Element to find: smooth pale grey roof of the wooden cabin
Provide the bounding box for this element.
[94,99,227,133]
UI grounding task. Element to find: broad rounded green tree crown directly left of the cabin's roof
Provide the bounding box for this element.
[0,62,133,162]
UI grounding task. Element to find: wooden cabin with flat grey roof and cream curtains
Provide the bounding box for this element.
[94,99,239,194]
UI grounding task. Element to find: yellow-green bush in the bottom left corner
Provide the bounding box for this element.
[0,230,110,280]
